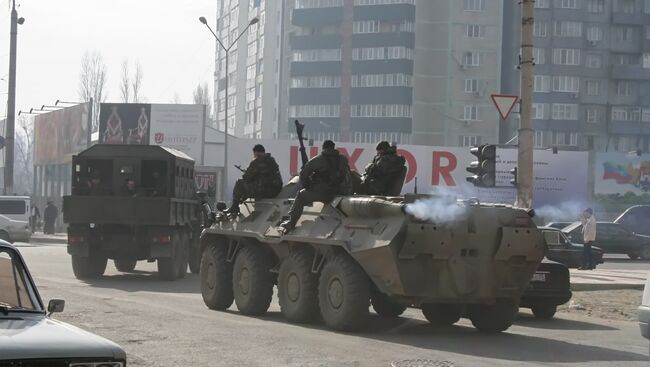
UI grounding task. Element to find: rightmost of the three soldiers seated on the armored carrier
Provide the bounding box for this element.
[357,141,406,195]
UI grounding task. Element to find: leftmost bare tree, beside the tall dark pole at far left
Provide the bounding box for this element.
[14,116,34,194]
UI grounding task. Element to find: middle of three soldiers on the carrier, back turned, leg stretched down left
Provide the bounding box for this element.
[280,140,352,233]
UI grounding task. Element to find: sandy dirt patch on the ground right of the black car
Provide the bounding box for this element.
[558,289,643,321]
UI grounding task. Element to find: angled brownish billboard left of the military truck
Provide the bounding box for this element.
[34,103,90,165]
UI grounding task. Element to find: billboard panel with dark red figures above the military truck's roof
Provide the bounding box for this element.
[99,103,151,144]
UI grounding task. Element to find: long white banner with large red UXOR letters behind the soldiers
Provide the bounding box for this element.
[227,139,589,207]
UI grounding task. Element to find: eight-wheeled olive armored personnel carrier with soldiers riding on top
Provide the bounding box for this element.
[200,123,546,332]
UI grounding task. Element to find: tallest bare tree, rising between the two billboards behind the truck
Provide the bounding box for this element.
[79,50,108,132]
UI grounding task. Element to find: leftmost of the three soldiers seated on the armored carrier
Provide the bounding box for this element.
[228,144,282,213]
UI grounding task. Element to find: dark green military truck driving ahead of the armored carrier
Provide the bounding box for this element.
[63,145,201,280]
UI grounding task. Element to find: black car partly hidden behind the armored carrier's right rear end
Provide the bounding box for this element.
[519,259,572,319]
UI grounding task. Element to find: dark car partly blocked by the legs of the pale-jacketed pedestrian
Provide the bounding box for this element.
[540,227,603,269]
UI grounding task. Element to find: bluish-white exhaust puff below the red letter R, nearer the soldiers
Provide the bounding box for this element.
[406,189,467,223]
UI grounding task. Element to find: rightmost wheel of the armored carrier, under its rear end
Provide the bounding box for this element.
[469,298,519,333]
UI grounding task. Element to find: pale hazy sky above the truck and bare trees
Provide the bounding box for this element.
[0,0,217,117]
